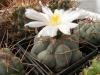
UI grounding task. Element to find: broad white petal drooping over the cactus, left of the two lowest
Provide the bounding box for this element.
[38,26,58,37]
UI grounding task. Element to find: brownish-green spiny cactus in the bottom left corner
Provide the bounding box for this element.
[0,48,25,75]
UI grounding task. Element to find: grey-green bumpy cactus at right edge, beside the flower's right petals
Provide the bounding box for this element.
[75,22,100,45]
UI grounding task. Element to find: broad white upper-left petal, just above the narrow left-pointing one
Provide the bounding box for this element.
[25,8,47,21]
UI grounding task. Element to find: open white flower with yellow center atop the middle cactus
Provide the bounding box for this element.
[25,6,80,37]
